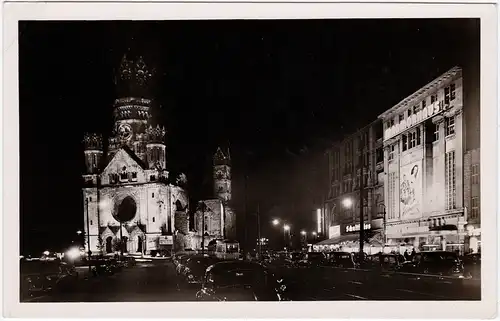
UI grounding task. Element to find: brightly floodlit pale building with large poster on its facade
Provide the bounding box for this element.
[379,67,480,252]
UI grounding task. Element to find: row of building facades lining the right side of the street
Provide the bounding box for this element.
[316,67,481,253]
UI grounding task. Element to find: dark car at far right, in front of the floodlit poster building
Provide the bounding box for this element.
[398,251,464,277]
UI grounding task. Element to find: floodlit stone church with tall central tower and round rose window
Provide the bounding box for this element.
[82,55,189,255]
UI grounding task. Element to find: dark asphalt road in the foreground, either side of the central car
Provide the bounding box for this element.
[23,261,481,302]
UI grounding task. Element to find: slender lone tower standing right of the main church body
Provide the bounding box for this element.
[214,147,231,203]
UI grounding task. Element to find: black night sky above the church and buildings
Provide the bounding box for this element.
[19,19,479,253]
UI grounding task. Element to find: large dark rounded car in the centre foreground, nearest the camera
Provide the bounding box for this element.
[196,261,286,301]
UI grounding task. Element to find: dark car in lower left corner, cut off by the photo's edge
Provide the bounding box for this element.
[20,260,77,298]
